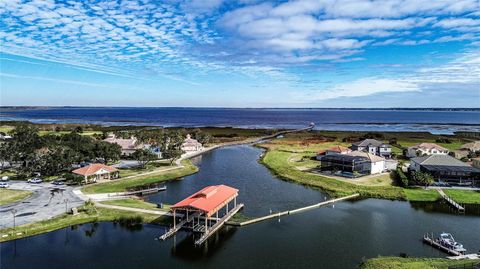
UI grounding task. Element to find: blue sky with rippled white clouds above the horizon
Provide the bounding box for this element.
[0,0,480,107]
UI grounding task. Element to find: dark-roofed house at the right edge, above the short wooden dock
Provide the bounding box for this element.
[409,155,480,185]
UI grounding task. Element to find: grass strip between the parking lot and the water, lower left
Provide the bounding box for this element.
[0,204,169,242]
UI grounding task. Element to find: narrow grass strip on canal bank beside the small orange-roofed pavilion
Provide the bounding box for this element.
[82,160,198,194]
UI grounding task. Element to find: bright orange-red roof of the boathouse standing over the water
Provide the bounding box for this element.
[171,185,238,216]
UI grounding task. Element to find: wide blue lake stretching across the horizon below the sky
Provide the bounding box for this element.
[1,105,480,133]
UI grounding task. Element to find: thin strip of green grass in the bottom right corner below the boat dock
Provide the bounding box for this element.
[360,257,479,269]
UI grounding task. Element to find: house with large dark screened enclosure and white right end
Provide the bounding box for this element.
[320,151,385,177]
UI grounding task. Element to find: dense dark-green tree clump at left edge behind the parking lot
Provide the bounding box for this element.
[0,124,121,178]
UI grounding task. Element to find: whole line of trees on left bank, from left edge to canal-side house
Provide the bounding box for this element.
[0,124,212,178]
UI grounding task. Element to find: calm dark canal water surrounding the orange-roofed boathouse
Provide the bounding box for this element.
[1,146,480,269]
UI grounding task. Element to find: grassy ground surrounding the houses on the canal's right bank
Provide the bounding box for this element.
[259,132,480,204]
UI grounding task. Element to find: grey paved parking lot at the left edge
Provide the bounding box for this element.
[0,181,84,229]
